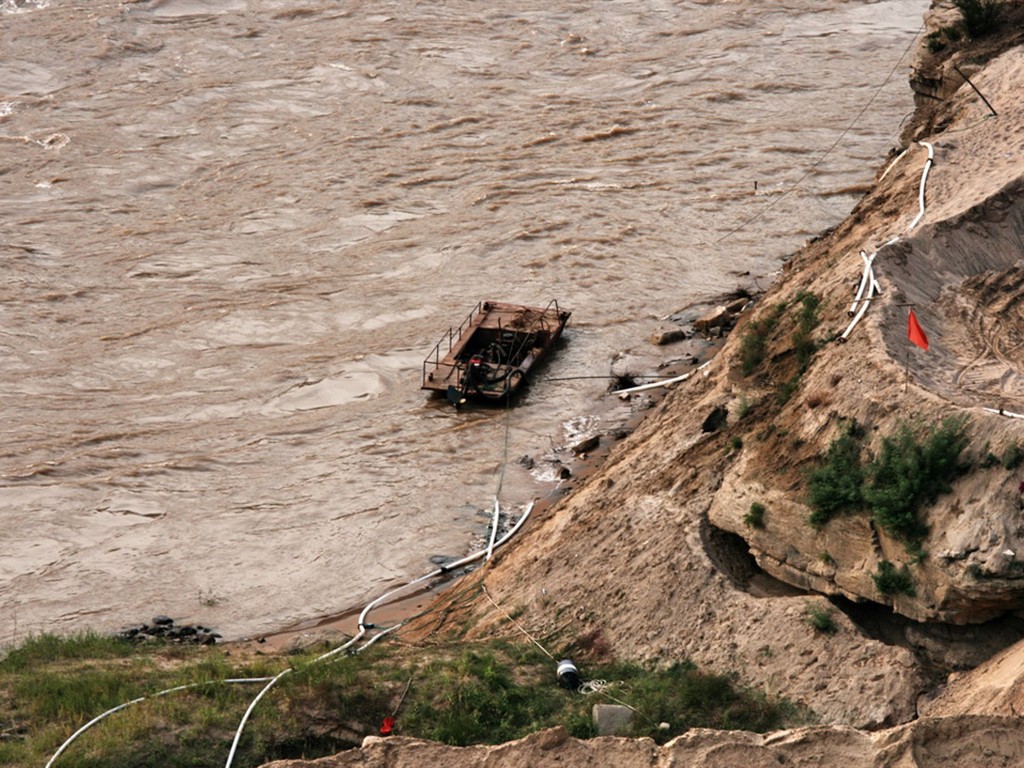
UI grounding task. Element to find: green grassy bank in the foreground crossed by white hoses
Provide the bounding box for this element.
[0,636,808,768]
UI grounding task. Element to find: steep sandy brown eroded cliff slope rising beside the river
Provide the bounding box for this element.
[456,4,1024,727]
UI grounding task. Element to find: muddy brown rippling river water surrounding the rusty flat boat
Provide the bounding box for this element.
[0,0,928,642]
